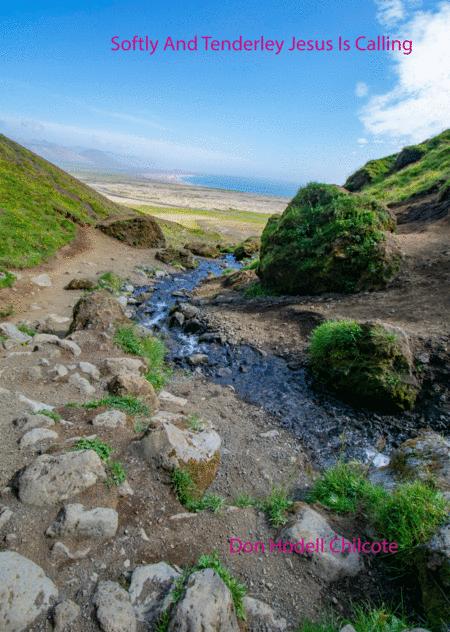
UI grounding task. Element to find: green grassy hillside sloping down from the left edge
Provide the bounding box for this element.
[0,134,121,269]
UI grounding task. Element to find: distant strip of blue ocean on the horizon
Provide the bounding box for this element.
[183,176,300,198]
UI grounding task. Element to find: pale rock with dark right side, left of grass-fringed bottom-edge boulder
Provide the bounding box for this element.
[129,562,180,626]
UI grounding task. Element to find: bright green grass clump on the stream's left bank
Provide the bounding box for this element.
[114,325,171,391]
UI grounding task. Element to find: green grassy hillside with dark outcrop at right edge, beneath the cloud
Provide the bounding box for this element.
[344,130,450,203]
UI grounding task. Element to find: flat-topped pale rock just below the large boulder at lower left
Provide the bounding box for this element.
[46,503,119,539]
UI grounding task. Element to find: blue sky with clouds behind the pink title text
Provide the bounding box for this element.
[0,0,450,183]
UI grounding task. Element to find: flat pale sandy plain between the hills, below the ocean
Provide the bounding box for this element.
[74,172,289,214]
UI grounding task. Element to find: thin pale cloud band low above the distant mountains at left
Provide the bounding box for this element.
[1,114,246,168]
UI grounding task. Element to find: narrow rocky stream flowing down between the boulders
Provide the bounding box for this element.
[134,255,426,467]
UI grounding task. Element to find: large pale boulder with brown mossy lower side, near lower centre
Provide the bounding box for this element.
[141,412,221,494]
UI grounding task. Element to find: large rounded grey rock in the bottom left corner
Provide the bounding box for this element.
[0,551,58,632]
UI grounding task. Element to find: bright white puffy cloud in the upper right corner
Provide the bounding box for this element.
[360,2,450,142]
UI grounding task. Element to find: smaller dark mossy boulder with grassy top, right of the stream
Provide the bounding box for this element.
[309,320,419,412]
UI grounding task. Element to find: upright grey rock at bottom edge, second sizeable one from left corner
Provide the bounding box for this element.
[94,582,136,632]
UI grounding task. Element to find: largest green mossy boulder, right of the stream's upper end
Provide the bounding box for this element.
[257,183,401,294]
